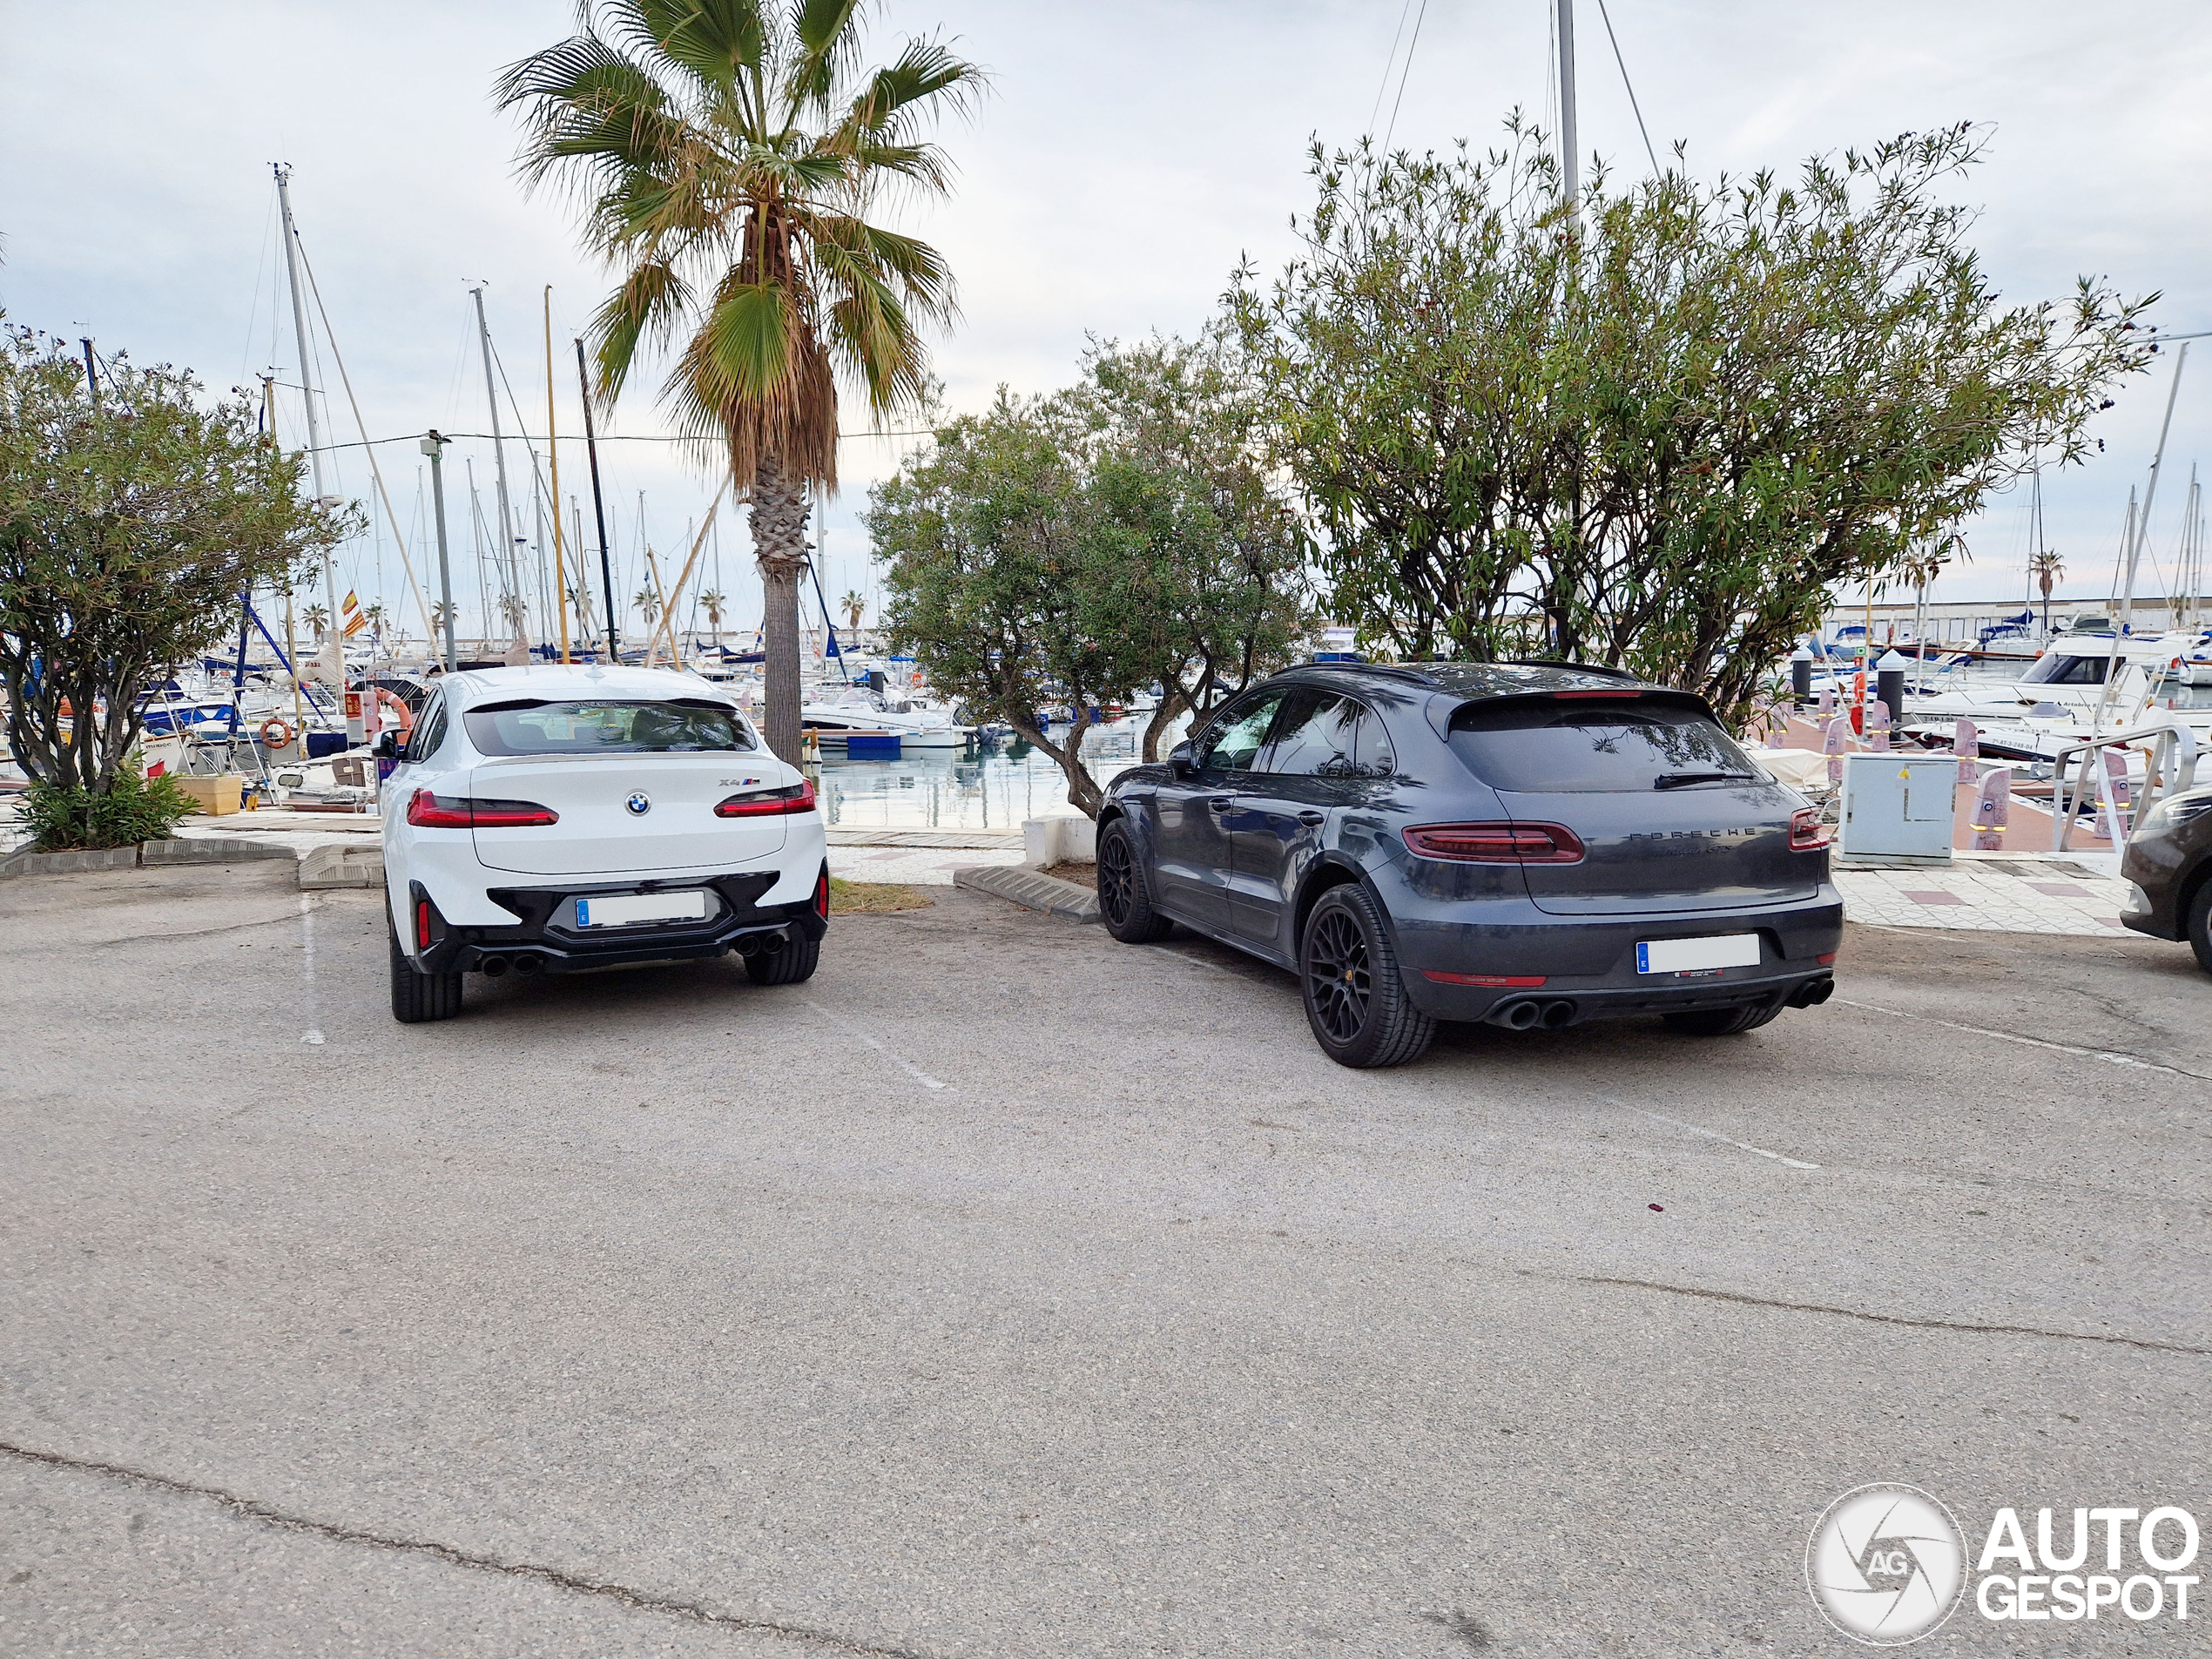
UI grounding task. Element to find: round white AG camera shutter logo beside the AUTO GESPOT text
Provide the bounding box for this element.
[1805,1482,1966,1648]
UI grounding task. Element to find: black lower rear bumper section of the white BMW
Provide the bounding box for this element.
[409,869,830,974]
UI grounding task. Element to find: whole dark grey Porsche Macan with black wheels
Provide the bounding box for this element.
[1097,664,1843,1066]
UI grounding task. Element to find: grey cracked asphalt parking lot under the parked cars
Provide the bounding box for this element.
[0,865,2212,1659]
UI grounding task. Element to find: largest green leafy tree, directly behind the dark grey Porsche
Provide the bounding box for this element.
[1232,122,2157,717]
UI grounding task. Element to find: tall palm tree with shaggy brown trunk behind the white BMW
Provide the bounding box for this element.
[498,0,982,761]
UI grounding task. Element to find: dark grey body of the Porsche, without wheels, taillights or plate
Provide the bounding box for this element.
[1099,664,1843,1027]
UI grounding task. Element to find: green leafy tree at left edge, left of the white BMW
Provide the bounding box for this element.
[0,329,361,845]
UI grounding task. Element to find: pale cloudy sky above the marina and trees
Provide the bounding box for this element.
[0,0,2212,645]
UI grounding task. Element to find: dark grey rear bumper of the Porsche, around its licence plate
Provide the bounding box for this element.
[1392,882,1843,1027]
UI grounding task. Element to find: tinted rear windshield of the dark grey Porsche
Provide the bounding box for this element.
[1451,701,1763,794]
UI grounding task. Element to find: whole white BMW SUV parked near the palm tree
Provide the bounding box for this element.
[381,666,830,1024]
